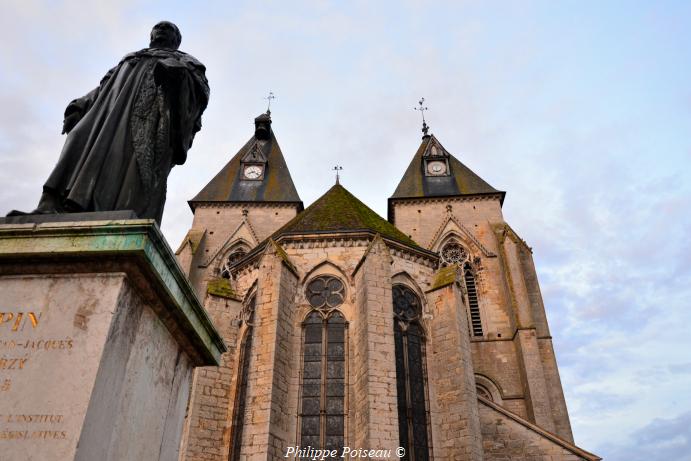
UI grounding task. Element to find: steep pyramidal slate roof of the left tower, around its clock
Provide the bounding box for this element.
[188,120,302,210]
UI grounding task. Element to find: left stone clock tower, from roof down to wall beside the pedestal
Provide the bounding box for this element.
[176,111,303,460]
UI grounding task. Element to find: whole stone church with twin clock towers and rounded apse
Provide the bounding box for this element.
[176,112,600,461]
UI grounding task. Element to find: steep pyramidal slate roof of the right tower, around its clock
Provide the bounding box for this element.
[389,135,506,203]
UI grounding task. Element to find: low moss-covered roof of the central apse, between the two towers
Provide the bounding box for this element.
[273,184,418,247]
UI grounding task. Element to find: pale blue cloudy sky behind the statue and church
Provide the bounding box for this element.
[0,0,691,461]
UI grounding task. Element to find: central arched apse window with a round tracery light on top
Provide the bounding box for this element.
[300,276,346,452]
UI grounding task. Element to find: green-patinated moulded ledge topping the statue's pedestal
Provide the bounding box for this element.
[0,219,227,365]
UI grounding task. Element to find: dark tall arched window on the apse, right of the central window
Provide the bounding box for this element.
[393,285,429,461]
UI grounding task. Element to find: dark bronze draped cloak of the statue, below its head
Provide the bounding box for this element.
[44,48,209,223]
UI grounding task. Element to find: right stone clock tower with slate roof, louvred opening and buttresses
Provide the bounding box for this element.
[388,131,573,442]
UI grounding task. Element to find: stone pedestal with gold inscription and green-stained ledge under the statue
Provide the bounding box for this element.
[0,220,225,461]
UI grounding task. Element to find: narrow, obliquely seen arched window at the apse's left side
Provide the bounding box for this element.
[230,297,256,461]
